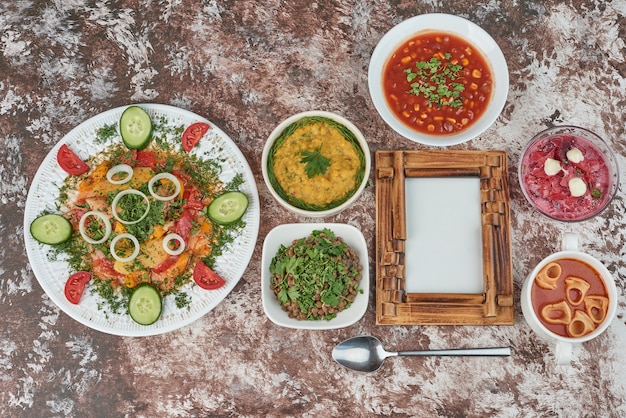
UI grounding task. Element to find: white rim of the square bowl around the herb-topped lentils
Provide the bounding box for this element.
[261,223,370,330]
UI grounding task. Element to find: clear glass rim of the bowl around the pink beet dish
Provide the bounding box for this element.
[517,125,620,223]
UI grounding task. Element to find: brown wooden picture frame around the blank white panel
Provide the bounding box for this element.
[376,150,514,325]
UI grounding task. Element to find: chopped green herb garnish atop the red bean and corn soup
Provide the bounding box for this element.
[404,53,465,108]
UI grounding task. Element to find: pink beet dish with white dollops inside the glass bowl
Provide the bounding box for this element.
[521,134,611,221]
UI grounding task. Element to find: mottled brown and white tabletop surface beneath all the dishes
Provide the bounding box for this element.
[0,0,626,417]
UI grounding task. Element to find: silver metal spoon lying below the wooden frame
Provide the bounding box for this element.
[333,335,511,373]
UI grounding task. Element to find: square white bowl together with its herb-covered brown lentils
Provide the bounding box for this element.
[261,223,369,329]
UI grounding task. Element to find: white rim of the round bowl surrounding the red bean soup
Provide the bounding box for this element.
[368,13,509,146]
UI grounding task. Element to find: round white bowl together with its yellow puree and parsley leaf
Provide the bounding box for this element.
[262,111,371,217]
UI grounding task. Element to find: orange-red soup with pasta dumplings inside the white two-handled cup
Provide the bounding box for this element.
[530,258,608,337]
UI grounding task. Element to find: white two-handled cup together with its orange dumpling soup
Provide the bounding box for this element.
[521,233,617,365]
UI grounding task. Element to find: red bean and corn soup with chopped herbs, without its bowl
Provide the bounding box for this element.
[383,32,494,135]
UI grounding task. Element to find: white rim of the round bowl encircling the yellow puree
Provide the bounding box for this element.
[261,110,371,218]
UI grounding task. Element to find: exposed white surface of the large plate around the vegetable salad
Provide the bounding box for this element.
[24,104,260,336]
